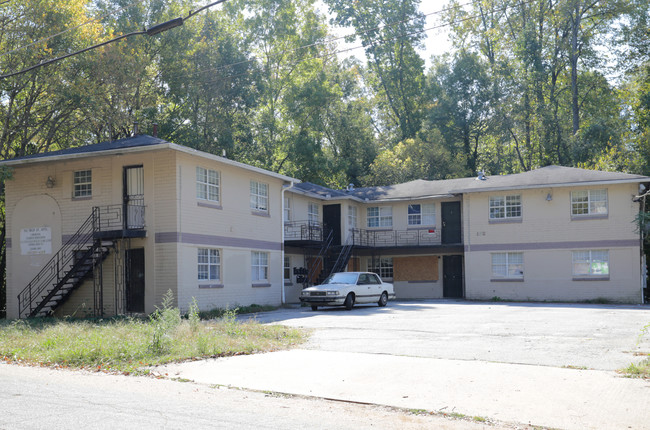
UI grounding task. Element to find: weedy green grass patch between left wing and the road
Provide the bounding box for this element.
[0,296,305,373]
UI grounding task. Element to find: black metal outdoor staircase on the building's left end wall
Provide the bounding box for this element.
[18,207,112,318]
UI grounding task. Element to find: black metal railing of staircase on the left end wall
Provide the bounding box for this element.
[18,207,99,318]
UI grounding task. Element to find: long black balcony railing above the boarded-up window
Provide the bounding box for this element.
[350,228,440,247]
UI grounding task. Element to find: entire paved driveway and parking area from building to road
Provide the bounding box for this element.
[157,301,650,429]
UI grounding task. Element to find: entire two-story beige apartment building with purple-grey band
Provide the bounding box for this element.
[0,135,650,318]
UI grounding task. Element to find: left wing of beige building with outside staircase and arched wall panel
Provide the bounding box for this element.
[2,135,295,318]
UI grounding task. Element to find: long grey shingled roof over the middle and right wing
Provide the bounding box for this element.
[291,166,650,201]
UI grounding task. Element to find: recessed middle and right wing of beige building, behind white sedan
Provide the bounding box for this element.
[285,166,650,303]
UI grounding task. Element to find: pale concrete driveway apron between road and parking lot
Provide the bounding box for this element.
[156,350,650,429]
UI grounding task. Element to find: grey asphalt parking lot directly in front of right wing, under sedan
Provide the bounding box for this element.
[248,300,650,370]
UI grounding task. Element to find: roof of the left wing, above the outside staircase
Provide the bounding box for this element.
[0,134,300,182]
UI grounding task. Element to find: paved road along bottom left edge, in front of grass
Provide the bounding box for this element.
[0,363,506,430]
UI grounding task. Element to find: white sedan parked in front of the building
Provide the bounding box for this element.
[300,272,395,311]
